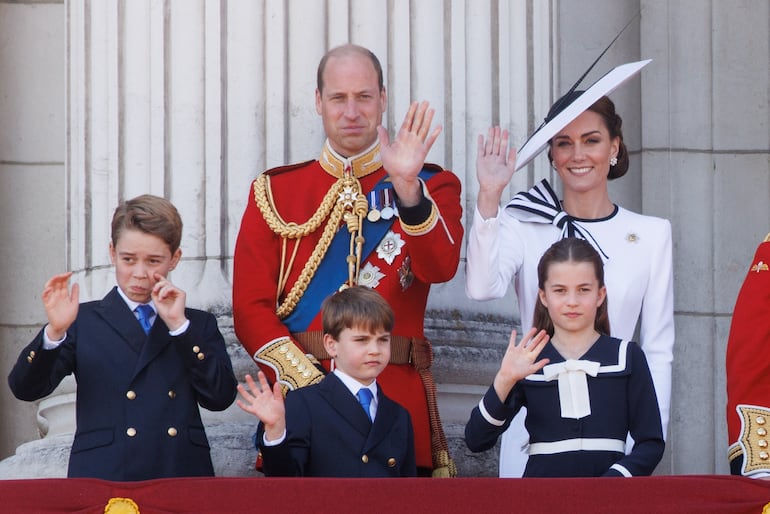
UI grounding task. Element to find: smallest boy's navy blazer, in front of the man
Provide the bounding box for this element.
[257,373,417,478]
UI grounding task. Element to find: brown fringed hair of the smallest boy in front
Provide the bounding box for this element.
[321,286,394,340]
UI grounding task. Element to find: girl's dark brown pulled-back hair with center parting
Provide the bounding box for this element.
[532,237,610,336]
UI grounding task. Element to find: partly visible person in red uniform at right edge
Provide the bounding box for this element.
[726,234,770,478]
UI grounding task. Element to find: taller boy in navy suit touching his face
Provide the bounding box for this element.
[8,195,237,481]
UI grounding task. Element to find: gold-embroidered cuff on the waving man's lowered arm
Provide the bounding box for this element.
[254,337,324,394]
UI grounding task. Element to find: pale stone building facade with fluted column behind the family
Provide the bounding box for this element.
[0,0,770,478]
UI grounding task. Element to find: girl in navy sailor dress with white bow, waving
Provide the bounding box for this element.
[465,238,665,477]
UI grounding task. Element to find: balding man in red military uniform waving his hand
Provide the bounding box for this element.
[233,45,463,476]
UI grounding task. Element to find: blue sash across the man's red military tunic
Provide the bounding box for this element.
[282,168,436,333]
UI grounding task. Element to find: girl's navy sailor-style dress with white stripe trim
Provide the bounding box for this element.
[465,335,665,477]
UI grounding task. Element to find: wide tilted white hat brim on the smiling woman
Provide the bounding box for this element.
[516,59,652,170]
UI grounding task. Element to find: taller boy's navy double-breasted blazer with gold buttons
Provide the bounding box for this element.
[8,288,237,481]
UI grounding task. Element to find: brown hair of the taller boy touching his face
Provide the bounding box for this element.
[111,195,182,254]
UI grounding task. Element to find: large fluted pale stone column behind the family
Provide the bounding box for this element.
[0,0,553,476]
